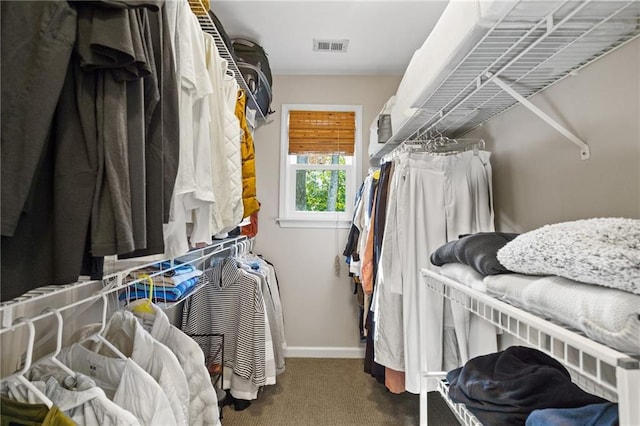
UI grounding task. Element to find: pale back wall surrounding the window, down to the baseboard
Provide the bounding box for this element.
[254,75,400,356]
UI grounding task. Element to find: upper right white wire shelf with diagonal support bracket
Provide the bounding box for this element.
[370,0,640,160]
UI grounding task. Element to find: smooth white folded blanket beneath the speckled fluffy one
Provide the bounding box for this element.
[484,274,640,354]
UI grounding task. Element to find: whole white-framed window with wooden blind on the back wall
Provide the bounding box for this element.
[279,104,362,228]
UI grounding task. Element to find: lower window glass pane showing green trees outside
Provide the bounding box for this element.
[296,170,347,212]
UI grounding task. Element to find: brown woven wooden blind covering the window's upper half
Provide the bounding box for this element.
[289,111,356,155]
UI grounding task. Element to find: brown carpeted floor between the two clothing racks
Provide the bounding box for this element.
[222,358,459,426]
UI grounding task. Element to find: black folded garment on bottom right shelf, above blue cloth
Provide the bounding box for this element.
[447,346,607,426]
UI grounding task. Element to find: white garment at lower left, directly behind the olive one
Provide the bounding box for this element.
[2,374,140,426]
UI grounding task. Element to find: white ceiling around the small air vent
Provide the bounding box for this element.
[210,0,447,75]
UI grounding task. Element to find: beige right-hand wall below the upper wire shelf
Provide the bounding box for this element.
[467,40,640,232]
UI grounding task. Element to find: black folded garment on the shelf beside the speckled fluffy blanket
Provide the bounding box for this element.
[431,232,520,275]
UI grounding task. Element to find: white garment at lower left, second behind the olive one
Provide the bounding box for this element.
[29,343,177,426]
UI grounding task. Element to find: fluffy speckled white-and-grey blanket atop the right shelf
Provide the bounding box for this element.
[498,218,640,294]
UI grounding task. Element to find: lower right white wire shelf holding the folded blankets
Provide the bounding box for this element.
[419,269,640,426]
